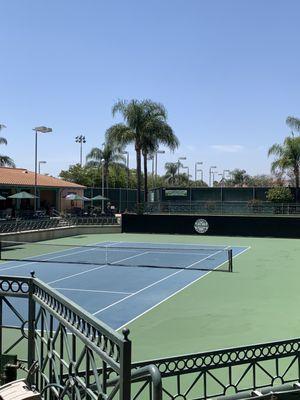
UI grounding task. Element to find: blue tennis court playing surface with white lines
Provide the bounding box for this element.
[0,242,248,329]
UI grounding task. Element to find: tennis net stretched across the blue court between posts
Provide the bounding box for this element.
[0,240,233,272]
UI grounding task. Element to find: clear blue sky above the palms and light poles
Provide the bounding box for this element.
[0,0,300,182]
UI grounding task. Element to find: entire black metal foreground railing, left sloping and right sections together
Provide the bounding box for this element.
[0,276,300,400]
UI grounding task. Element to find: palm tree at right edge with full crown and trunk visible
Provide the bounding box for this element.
[268,136,300,188]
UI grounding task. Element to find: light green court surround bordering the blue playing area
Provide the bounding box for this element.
[2,234,300,361]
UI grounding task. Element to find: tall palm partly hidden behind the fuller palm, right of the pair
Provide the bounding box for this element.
[142,118,179,201]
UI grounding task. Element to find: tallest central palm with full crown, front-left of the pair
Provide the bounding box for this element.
[106,100,176,204]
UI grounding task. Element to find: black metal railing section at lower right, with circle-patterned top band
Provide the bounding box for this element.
[132,339,300,400]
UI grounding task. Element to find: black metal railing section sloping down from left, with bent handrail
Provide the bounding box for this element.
[0,276,161,400]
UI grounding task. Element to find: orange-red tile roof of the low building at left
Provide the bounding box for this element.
[0,167,85,189]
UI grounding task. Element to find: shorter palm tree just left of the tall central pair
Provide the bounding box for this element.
[86,142,125,187]
